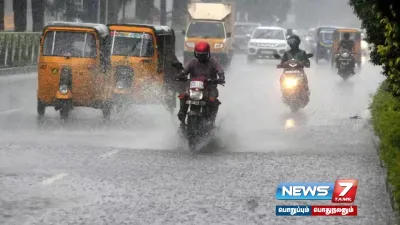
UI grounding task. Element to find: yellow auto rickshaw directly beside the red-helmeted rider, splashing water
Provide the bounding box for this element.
[108,24,177,112]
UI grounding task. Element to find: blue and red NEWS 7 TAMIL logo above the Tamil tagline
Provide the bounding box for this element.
[276,179,358,203]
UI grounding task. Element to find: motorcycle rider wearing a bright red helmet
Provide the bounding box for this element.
[177,41,225,127]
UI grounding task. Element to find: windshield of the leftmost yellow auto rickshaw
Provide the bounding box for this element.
[43,31,97,58]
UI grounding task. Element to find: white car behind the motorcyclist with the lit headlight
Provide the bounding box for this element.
[247,27,289,61]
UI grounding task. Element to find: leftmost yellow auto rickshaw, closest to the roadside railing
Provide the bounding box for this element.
[37,22,112,119]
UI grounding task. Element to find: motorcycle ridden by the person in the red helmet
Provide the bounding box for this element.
[173,63,220,151]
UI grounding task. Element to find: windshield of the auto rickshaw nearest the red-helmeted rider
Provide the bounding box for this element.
[109,31,154,57]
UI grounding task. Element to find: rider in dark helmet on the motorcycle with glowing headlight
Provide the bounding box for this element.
[280,34,311,101]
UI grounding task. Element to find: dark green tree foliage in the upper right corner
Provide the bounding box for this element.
[349,0,400,97]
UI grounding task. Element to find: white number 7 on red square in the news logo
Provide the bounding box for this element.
[332,180,358,203]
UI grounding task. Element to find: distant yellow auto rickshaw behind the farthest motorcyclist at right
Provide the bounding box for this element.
[331,28,362,68]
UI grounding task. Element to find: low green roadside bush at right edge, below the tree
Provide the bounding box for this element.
[371,81,400,205]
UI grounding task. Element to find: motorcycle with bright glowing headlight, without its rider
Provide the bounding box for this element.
[275,54,313,112]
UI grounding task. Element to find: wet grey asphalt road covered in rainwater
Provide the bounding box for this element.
[0,53,393,225]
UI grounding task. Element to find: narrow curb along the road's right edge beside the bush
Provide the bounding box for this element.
[369,125,400,224]
